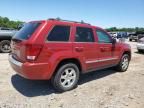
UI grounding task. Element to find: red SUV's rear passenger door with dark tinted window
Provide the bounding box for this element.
[73,27,98,71]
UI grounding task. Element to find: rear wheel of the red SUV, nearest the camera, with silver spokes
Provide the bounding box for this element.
[51,63,79,92]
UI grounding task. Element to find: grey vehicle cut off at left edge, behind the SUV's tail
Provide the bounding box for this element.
[0,27,17,53]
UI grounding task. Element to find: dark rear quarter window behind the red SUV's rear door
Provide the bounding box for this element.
[47,25,70,41]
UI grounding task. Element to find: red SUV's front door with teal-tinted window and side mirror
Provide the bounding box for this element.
[96,29,118,67]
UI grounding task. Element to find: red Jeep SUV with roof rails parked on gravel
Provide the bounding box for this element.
[9,19,131,91]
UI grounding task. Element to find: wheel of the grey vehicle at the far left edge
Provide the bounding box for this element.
[0,40,11,53]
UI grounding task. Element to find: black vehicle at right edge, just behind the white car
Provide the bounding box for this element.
[129,32,144,42]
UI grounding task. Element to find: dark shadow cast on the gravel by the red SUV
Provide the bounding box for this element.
[11,68,116,97]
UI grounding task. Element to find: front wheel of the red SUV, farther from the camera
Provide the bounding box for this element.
[116,54,130,72]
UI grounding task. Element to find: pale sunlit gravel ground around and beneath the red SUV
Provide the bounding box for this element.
[0,42,144,108]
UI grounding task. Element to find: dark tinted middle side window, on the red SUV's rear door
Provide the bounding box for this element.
[75,27,94,42]
